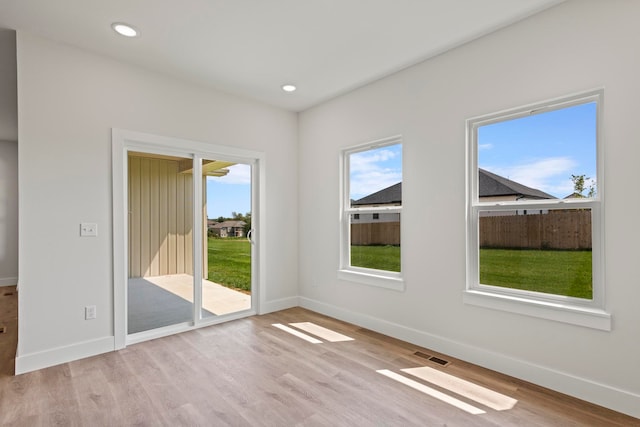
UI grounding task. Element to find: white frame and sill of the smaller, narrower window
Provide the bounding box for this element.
[338,135,405,291]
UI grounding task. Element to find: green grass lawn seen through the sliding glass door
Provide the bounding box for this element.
[208,237,251,292]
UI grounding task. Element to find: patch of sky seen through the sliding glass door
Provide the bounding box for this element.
[207,163,251,219]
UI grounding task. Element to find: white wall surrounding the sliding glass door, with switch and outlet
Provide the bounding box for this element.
[16,32,297,372]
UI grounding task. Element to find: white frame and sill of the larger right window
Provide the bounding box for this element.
[463,89,611,330]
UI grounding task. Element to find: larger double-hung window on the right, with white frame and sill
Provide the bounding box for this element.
[465,91,610,330]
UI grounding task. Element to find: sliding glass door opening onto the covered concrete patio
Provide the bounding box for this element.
[126,149,255,337]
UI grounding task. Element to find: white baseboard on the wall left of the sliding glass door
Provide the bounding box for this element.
[16,337,115,375]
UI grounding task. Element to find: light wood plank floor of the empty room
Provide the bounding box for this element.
[0,290,640,426]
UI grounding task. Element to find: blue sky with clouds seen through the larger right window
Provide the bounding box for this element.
[478,103,597,198]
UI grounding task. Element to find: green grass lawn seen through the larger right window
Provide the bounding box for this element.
[480,249,593,299]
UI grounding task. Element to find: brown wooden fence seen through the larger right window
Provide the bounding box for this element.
[479,209,591,249]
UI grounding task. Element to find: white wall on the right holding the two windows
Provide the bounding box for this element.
[299,0,640,417]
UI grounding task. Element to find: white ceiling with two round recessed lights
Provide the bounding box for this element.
[0,0,562,111]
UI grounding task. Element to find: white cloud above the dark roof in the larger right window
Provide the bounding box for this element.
[485,157,578,197]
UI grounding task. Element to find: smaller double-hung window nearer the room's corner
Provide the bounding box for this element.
[339,137,403,290]
